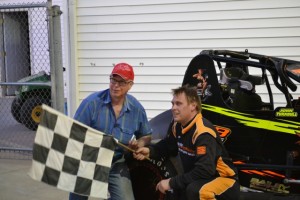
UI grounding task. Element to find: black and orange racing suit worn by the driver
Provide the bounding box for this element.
[150,114,240,200]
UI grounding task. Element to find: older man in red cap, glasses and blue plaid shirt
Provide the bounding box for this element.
[69,63,152,200]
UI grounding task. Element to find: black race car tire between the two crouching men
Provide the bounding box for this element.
[128,159,177,200]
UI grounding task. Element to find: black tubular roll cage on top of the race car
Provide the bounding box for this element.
[200,49,300,109]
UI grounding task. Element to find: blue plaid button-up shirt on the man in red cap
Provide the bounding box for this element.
[74,89,152,158]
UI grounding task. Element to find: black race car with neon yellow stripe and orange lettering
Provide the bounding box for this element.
[131,49,300,200]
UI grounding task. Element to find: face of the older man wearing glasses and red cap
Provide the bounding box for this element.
[109,75,133,98]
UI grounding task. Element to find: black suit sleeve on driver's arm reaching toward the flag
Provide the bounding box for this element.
[149,123,178,158]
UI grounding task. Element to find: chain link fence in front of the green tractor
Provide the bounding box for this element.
[0,2,62,159]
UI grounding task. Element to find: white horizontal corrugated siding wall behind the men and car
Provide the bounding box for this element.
[71,0,300,118]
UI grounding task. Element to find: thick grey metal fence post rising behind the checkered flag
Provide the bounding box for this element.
[47,0,64,113]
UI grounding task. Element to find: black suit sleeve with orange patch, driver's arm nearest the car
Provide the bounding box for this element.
[170,133,217,189]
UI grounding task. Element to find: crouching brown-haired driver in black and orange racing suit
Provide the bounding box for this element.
[134,86,240,200]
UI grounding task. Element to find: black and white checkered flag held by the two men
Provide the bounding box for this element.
[28,105,117,199]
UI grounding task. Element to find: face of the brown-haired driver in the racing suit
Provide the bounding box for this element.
[172,93,197,126]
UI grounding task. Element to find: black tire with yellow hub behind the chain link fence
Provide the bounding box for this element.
[20,97,50,131]
